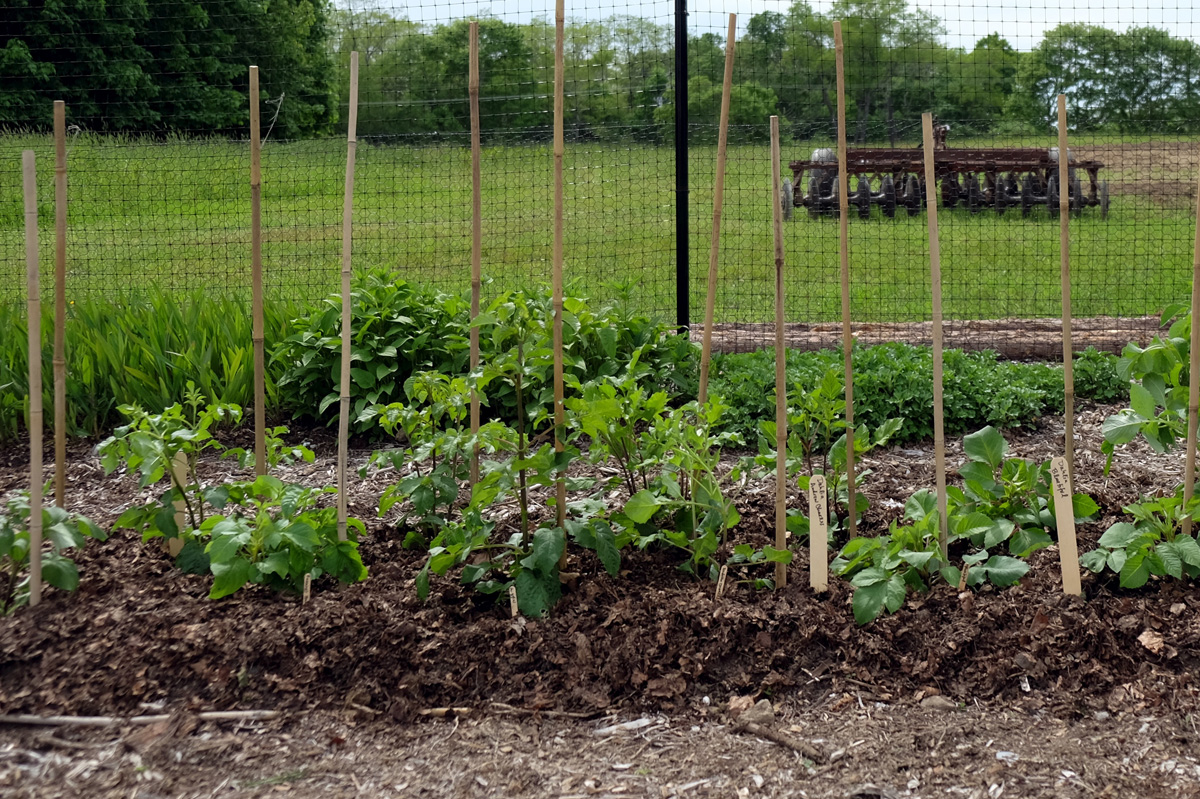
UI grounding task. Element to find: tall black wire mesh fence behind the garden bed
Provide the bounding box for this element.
[0,0,1200,355]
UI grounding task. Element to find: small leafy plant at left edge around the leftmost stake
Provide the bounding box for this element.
[0,491,107,615]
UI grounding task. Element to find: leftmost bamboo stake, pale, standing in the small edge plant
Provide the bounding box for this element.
[22,150,42,607]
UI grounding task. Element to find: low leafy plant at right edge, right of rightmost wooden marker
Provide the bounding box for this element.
[1080,487,1200,588]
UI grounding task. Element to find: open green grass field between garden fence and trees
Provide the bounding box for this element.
[0,137,1195,322]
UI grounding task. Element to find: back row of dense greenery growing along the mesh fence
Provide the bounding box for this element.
[0,270,1128,443]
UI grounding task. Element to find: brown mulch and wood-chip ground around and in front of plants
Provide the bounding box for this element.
[0,407,1200,799]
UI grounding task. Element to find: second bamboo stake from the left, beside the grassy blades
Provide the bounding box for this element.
[54,100,67,507]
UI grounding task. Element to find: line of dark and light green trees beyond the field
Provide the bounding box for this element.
[0,0,1200,143]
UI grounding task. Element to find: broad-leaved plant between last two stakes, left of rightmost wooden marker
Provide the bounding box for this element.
[947,426,1099,558]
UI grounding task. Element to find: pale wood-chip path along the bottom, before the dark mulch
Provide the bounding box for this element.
[0,690,1200,799]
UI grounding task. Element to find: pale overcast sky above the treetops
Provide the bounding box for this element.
[336,0,1200,50]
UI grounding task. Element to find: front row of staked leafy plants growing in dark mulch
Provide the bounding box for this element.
[0,302,1200,624]
